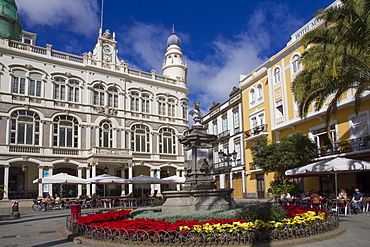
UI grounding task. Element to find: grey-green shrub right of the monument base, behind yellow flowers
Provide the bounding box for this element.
[236,203,287,222]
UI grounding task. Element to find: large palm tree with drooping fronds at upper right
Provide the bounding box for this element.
[292,0,370,137]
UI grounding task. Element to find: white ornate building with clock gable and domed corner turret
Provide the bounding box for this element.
[0,0,189,198]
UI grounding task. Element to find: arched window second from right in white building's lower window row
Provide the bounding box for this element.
[131,124,150,152]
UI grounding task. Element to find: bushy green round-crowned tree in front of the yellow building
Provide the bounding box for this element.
[251,132,318,181]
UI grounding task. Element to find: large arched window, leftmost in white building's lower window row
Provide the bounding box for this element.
[10,110,40,145]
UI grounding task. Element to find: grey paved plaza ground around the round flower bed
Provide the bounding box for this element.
[0,200,370,247]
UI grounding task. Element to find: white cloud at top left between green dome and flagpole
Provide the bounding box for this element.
[16,0,100,35]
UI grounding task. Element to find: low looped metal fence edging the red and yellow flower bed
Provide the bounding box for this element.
[67,212,339,245]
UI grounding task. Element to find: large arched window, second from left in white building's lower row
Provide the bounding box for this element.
[53,115,78,148]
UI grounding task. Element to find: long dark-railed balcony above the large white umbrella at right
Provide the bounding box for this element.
[318,136,370,156]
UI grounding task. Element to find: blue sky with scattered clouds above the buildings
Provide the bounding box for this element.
[16,0,334,113]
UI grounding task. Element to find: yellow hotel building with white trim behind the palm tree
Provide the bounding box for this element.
[239,1,370,198]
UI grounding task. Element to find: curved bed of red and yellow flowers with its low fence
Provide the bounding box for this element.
[68,206,339,244]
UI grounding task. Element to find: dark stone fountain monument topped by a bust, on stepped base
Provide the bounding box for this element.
[162,101,235,213]
